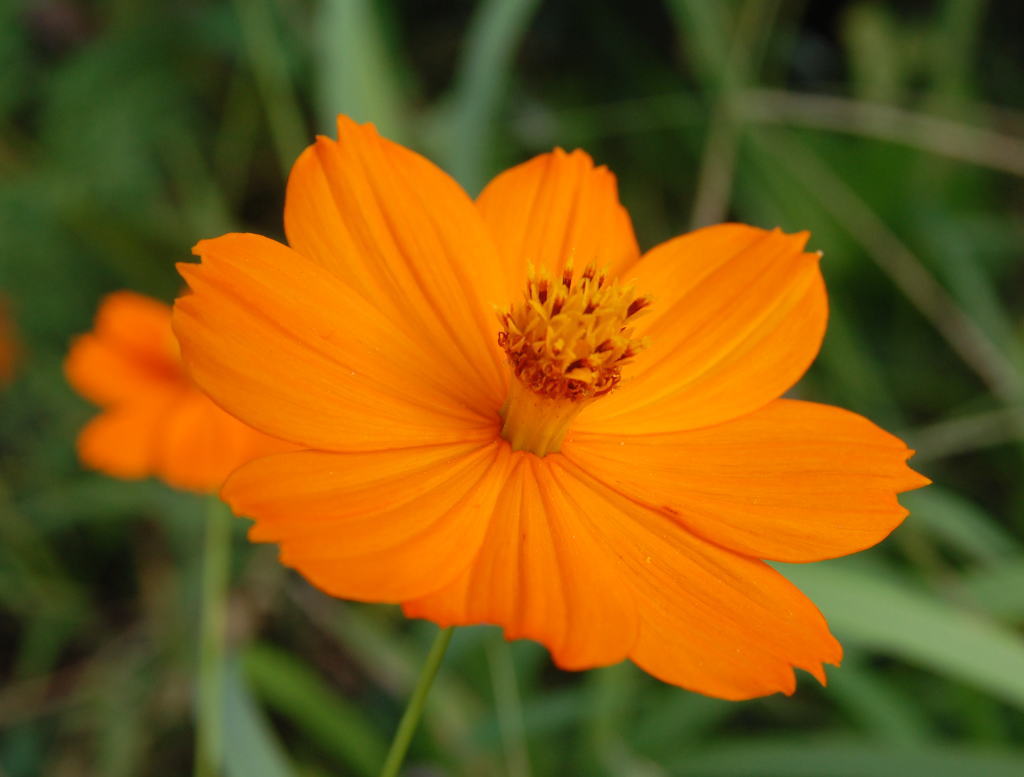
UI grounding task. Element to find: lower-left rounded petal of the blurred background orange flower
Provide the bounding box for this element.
[78,390,181,480]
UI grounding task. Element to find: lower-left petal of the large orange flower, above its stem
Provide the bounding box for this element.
[222,442,510,602]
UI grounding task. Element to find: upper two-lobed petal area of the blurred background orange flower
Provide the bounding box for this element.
[65,291,185,404]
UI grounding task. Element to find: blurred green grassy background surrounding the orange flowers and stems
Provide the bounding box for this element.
[0,0,1024,777]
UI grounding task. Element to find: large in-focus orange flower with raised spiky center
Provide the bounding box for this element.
[175,118,927,699]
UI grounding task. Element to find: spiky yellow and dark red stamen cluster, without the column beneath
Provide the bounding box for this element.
[498,262,650,401]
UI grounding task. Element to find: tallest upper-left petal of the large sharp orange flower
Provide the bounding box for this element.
[285,117,507,403]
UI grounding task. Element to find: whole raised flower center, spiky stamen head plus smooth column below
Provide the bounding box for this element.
[498,261,650,456]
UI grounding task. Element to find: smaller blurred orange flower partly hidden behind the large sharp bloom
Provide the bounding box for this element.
[65,292,291,491]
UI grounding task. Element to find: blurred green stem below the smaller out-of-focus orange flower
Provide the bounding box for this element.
[194,497,231,777]
